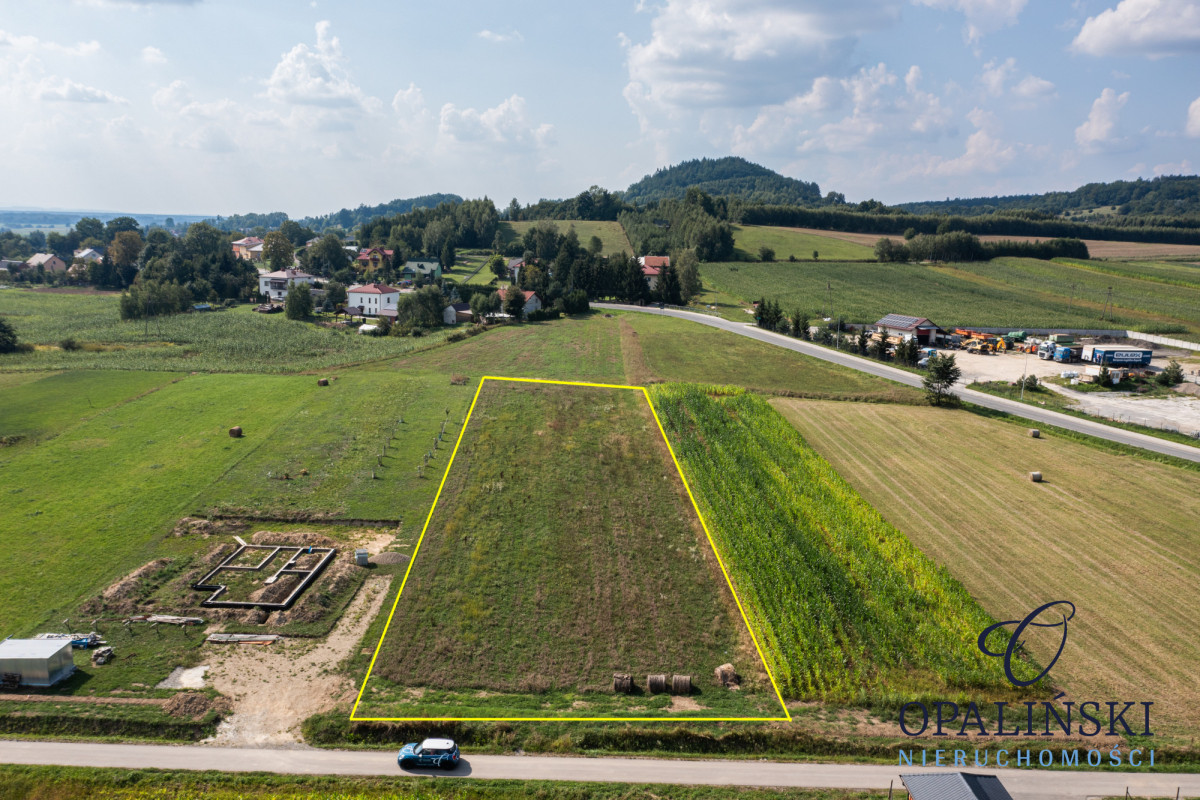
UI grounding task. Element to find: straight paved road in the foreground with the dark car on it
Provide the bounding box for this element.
[0,741,1200,800]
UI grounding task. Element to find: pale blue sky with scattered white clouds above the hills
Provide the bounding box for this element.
[0,0,1200,217]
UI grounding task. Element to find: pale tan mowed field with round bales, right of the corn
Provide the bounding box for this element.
[773,399,1200,739]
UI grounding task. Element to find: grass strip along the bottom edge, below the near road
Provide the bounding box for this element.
[0,764,887,800]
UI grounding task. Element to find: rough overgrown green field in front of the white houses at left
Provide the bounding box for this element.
[0,289,449,373]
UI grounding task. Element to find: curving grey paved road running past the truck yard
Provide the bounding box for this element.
[592,302,1200,462]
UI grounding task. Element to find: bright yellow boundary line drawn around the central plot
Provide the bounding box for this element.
[350,375,792,722]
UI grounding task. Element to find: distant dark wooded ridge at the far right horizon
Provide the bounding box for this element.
[895,175,1200,217]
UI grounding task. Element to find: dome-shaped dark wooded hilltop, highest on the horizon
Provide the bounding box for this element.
[622,156,821,205]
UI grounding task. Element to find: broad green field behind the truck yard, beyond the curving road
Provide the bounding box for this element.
[701,258,1200,338]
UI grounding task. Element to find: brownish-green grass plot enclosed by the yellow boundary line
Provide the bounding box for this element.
[356,381,782,718]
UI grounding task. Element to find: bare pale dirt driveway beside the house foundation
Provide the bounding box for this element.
[205,577,391,747]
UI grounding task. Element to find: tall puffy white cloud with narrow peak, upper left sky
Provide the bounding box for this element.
[266,20,378,108]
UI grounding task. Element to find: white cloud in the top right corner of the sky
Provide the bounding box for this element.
[1070,0,1200,58]
